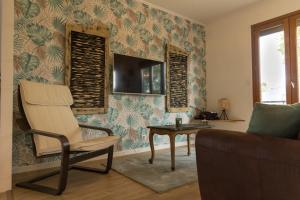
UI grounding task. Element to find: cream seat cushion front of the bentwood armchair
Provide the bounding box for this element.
[70,136,120,151]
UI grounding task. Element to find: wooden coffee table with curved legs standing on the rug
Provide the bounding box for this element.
[147,124,211,171]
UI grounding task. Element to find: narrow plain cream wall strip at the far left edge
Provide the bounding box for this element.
[0,0,14,193]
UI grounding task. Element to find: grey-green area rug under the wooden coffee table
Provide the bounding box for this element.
[113,147,197,193]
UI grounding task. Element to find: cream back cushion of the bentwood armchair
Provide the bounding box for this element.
[20,80,83,156]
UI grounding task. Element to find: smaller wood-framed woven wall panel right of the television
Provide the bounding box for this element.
[166,44,189,112]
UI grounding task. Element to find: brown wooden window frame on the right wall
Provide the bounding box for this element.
[251,10,300,104]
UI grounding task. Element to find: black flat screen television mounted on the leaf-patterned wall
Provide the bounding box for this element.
[113,54,165,95]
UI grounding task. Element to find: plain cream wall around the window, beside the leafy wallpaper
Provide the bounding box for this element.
[206,0,300,131]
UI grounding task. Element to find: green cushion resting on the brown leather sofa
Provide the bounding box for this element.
[247,103,300,139]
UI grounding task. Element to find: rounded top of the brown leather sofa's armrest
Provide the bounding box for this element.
[195,129,300,166]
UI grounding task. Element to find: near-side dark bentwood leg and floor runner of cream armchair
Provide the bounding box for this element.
[16,148,69,195]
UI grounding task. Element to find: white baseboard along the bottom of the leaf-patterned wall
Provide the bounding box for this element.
[13,140,193,174]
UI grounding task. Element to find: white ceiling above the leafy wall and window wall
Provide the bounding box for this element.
[144,0,263,23]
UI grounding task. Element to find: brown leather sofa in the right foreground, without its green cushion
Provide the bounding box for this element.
[195,129,300,200]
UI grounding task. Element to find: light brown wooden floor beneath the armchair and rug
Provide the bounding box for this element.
[13,162,200,200]
